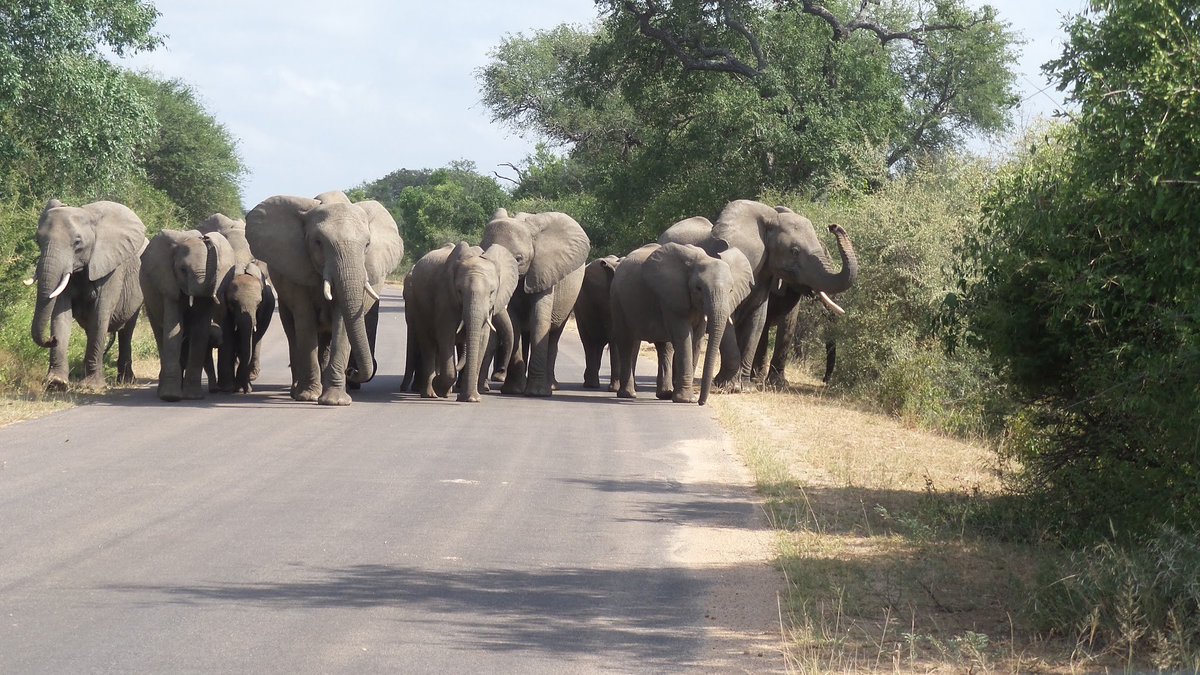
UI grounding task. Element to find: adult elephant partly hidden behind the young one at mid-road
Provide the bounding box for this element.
[481,209,592,396]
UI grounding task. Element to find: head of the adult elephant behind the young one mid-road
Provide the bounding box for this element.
[481,209,592,293]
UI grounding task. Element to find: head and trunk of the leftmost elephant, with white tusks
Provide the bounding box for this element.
[31,199,146,347]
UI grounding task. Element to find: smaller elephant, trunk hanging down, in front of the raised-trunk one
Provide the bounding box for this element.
[612,244,750,405]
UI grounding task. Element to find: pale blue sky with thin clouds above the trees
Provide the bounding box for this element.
[122,0,1086,208]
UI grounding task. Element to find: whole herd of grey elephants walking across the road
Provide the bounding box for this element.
[28,192,858,405]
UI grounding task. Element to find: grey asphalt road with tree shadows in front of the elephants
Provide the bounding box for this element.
[0,289,767,674]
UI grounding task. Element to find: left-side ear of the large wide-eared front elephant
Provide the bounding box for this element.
[246,195,322,286]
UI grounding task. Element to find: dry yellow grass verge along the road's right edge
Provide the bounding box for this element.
[713,374,1094,673]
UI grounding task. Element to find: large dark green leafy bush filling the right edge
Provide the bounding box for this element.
[956,0,1200,538]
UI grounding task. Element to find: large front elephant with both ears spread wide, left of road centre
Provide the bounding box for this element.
[246,192,404,405]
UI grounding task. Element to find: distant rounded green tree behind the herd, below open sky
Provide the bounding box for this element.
[380,161,508,261]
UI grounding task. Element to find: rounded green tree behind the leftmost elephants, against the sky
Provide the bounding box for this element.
[130,74,246,226]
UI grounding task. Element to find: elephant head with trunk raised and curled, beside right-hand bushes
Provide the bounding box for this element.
[713,199,858,295]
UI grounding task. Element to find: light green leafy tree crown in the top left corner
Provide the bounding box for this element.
[0,0,160,198]
